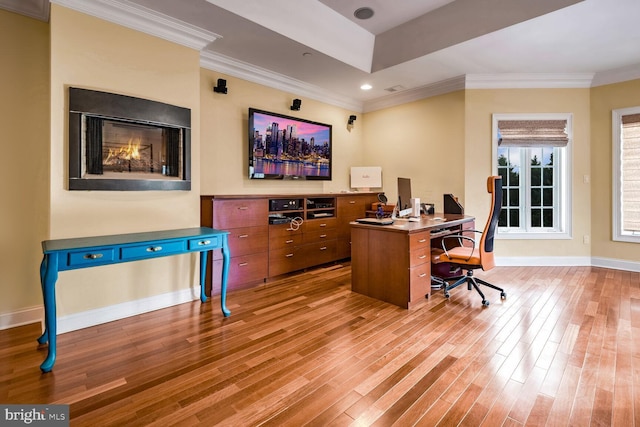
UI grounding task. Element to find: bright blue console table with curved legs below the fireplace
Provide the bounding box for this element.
[38,227,231,372]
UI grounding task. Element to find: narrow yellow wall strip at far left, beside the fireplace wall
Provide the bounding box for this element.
[0,10,49,326]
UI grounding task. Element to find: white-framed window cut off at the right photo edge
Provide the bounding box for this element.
[611,107,640,243]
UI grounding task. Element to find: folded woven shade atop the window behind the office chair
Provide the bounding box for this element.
[498,120,569,147]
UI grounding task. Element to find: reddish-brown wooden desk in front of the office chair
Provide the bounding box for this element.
[351,213,475,308]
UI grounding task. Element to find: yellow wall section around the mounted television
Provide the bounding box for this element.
[200,69,364,195]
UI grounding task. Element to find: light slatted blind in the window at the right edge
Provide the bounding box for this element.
[621,114,640,231]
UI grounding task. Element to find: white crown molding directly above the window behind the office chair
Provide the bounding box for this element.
[465,73,594,89]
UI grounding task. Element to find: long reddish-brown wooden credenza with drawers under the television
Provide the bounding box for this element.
[200,193,378,290]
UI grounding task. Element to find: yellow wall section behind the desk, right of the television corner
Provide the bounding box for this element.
[358,91,465,210]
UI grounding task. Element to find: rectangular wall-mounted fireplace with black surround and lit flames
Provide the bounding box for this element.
[69,88,191,191]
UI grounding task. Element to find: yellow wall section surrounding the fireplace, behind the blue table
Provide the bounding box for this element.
[49,4,200,316]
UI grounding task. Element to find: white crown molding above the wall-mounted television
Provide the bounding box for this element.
[200,51,363,113]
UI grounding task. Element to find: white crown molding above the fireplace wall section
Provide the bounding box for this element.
[51,0,221,50]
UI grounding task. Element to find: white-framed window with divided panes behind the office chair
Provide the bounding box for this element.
[493,114,572,239]
